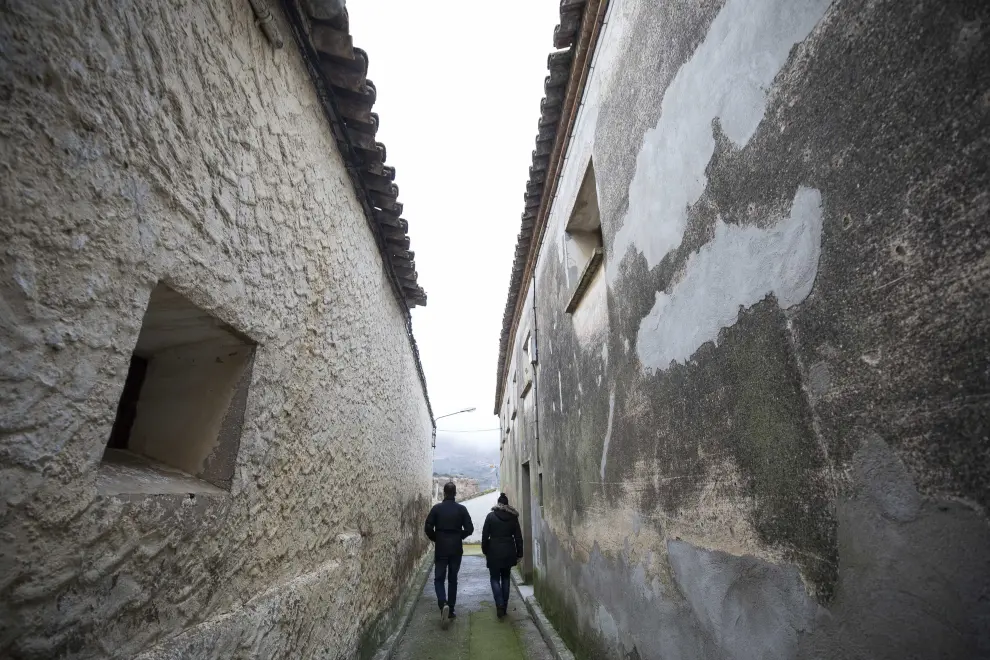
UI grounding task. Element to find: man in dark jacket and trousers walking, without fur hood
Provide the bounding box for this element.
[425,482,474,628]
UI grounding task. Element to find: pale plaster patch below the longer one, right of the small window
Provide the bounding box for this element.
[636,187,822,373]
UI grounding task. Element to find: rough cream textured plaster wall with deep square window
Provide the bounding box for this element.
[0,0,431,658]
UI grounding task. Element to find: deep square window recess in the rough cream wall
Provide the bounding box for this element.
[100,284,255,493]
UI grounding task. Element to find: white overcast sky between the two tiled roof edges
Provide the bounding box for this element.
[347,0,560,449]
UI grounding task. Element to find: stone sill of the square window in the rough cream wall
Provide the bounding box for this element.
[96,449,228,495]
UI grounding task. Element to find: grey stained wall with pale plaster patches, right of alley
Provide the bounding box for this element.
[500,0,990,660]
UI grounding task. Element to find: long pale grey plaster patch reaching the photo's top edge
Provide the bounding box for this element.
[608,0,830,282]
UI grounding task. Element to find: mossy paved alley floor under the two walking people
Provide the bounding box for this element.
[394,546,553,660]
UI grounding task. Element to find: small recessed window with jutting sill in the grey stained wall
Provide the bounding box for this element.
[564,161,605,314]
